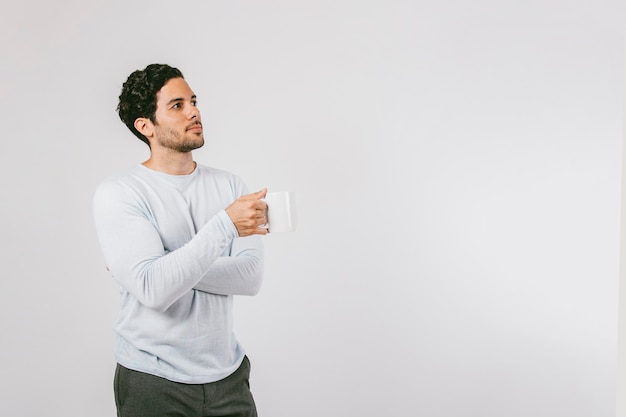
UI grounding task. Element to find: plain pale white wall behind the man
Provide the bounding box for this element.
[0,0,625,417]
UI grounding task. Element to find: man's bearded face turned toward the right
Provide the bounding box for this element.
[154,78,204,152]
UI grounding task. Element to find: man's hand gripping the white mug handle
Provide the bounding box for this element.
[226,188,268,237]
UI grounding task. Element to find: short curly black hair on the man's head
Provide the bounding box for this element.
[117,64,185,147]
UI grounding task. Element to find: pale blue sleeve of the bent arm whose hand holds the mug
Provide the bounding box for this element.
[93,182,237,311]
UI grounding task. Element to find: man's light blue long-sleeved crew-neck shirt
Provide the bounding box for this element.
[93,165,263,384]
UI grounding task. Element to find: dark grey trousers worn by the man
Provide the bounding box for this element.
[114,356,257,417]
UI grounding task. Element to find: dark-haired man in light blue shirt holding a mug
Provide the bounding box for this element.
[94,64,268,417]
